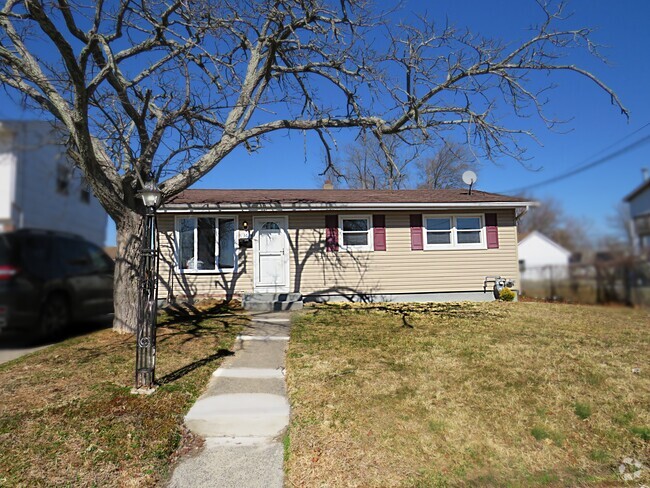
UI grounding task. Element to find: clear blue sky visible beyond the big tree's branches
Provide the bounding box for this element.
[0,0,650,244]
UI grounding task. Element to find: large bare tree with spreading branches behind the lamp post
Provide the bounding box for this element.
[0,0,626,330]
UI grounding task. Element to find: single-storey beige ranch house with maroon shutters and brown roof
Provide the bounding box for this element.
[158,189,531,301]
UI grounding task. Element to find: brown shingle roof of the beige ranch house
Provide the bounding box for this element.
[168,189,528,205]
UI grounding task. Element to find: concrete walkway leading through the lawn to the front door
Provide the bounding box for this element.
[169,312,290,488]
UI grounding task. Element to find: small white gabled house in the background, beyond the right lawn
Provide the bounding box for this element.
[518,230,571,282]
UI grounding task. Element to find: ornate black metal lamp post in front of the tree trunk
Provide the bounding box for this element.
[135,181,162,391]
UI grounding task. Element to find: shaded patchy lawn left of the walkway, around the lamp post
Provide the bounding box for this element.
[0,304,247,487]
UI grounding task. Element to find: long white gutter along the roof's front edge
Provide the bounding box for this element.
[158,202,537,214]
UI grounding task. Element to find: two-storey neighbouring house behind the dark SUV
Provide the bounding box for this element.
[0,121,108,246]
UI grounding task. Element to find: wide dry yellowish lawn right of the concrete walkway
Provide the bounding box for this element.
[285,302,650,487]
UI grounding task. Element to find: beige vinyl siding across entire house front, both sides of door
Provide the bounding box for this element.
[158,209,519,298]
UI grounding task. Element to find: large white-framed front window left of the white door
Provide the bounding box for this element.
[176,217,236,271]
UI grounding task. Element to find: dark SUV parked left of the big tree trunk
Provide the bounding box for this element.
[0,229,114,340]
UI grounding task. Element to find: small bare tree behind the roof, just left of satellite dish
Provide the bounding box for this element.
[417,142,478,190]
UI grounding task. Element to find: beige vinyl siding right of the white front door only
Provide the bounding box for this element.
[289,210,518,295]
